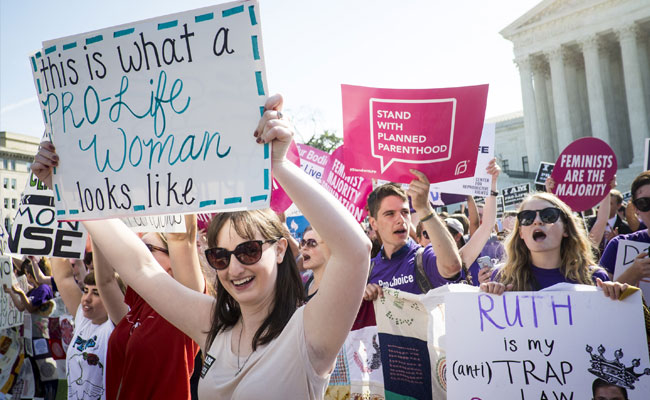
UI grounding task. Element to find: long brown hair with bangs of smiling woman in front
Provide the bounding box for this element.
[206,209,304,350]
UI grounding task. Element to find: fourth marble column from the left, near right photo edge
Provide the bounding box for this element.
[616,25,650,166]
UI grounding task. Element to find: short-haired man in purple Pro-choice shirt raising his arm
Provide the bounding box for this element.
[363,170,461,300]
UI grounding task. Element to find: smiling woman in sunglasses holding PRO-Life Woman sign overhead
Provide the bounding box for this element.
[32,95,370,399]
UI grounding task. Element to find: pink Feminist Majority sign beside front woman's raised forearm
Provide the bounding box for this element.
[321,146,372,222]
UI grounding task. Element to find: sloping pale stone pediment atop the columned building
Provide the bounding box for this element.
[500,0,607,39]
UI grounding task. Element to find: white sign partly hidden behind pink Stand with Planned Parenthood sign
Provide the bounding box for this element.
[431,124,496,197]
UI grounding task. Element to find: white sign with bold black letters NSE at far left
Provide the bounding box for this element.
[8,174,86,258]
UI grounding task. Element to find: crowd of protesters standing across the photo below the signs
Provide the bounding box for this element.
[4,95,650,400]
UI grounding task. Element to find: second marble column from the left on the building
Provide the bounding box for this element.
[546,46,573,152]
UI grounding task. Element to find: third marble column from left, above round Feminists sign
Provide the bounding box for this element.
[580,35,610,143]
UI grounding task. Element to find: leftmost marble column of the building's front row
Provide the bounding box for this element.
[515,56,541,171]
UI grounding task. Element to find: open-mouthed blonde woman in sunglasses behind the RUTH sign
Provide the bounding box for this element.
[481,193,627,299]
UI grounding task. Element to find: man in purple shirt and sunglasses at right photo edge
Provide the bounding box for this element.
[600,171,650,286]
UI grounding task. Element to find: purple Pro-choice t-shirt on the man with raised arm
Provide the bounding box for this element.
[368,238,460,294]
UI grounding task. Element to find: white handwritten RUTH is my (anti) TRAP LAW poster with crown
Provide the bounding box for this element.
[445,284,650,400]
